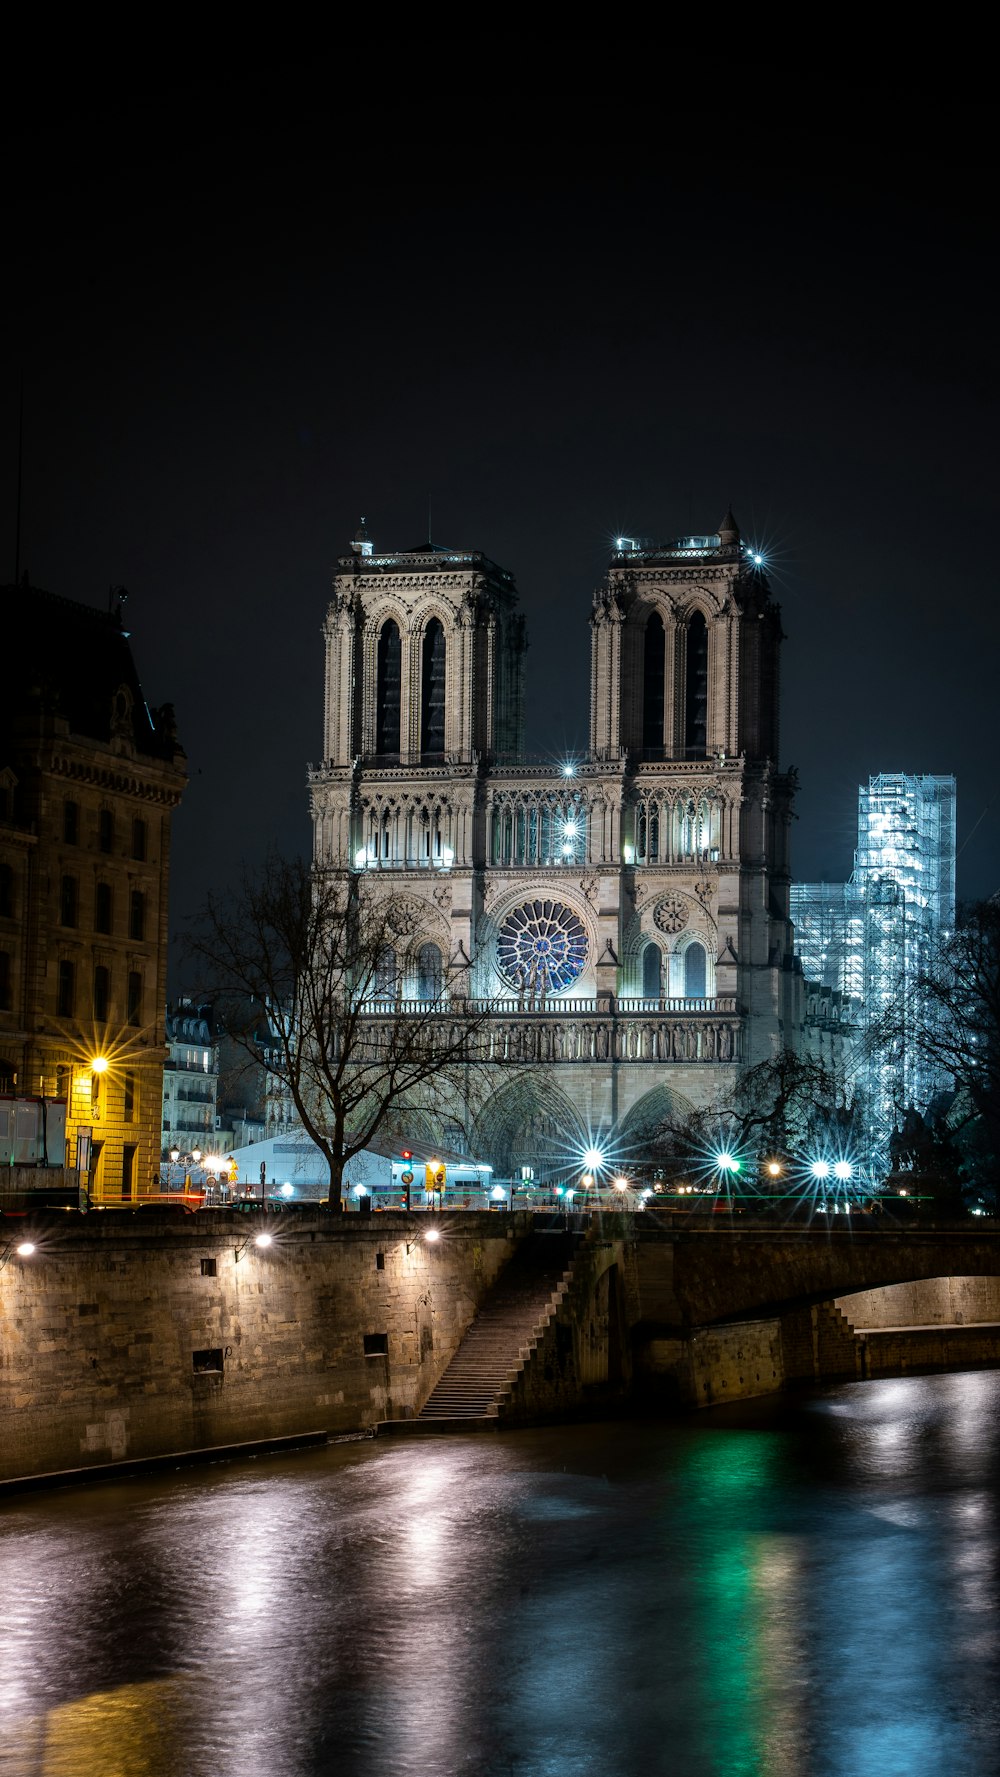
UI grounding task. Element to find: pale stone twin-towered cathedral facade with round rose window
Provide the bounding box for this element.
[309,514,803,1176]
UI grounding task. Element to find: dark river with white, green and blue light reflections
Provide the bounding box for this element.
[0,1372,1000,1777]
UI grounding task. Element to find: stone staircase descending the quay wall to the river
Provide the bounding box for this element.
[393,1226,584,1430]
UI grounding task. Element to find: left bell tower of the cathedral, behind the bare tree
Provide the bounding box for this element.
[309,521,526,997]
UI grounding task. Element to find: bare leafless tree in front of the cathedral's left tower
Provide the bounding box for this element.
[188,857,493,1207]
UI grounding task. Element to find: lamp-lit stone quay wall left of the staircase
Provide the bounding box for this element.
[0,1208,531,1480]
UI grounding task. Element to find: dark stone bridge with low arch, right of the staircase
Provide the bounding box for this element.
[623,1223,1000,1406]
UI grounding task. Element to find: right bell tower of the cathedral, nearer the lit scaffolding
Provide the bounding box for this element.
[590,512,798,1064]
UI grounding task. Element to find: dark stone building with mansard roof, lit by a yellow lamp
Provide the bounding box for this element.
[0,581,187,1201]
